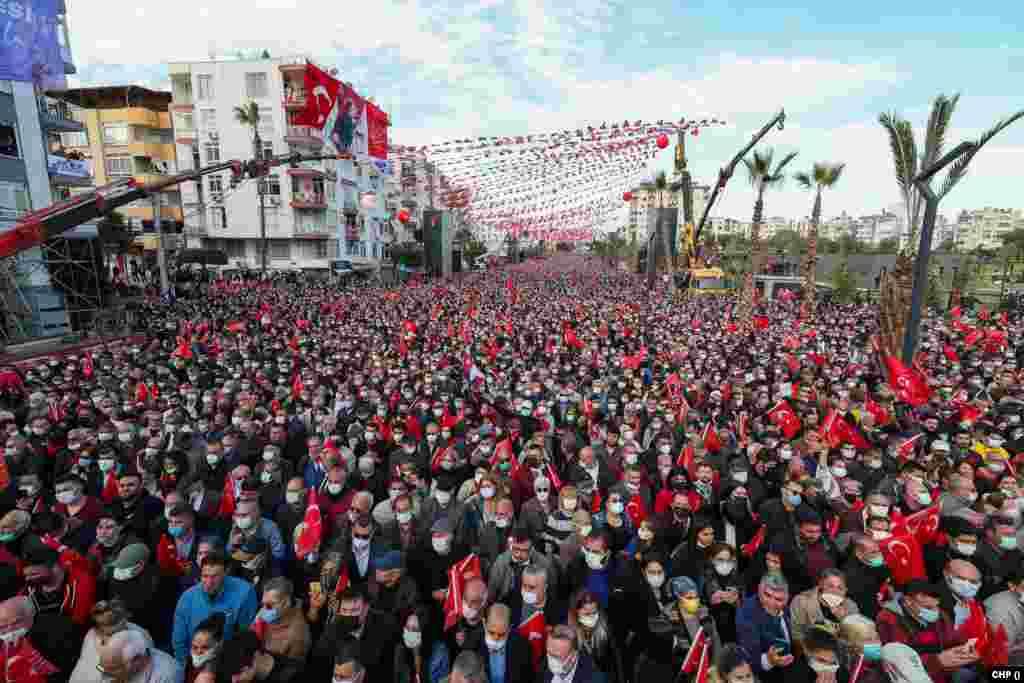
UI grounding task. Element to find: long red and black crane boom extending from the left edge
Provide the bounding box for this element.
[0,154,351,258]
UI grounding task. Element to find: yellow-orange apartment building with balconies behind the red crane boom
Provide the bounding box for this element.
[54,85,184,240]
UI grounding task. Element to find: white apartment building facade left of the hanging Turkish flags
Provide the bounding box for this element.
[168,57,337,270]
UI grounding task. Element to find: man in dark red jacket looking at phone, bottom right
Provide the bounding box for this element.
[876,580,978,683]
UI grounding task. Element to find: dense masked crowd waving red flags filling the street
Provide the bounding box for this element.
[0,255,1024,683]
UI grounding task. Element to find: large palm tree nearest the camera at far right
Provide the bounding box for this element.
[879,94,1024,361]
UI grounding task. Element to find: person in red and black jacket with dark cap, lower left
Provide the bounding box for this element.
[23,542,96,627]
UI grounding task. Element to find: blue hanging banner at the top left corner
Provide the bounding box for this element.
[0,0,68,90]
